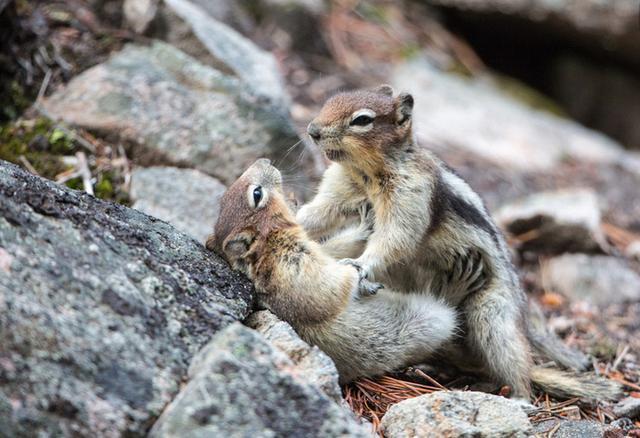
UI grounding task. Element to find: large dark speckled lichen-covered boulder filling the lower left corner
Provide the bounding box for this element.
[0,161,253,436]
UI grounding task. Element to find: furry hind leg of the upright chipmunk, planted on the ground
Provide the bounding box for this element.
[463,283,532,399]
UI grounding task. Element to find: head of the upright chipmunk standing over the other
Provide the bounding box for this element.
[307,85,413,166]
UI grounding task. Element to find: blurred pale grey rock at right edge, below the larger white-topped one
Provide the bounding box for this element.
[541,254,640,305]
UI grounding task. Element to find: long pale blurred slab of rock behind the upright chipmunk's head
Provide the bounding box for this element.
[392,60,638,172]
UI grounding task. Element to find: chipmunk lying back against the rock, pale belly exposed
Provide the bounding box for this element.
[206,159,465,383]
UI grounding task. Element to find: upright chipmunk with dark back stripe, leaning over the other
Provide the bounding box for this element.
[296,85,620,398]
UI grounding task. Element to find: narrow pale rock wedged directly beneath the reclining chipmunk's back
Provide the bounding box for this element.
[245,310,343,403]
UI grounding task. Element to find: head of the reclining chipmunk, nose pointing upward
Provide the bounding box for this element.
[206,158,294,268]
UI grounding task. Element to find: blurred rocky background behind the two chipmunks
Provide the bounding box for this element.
[0,0,640,430]
